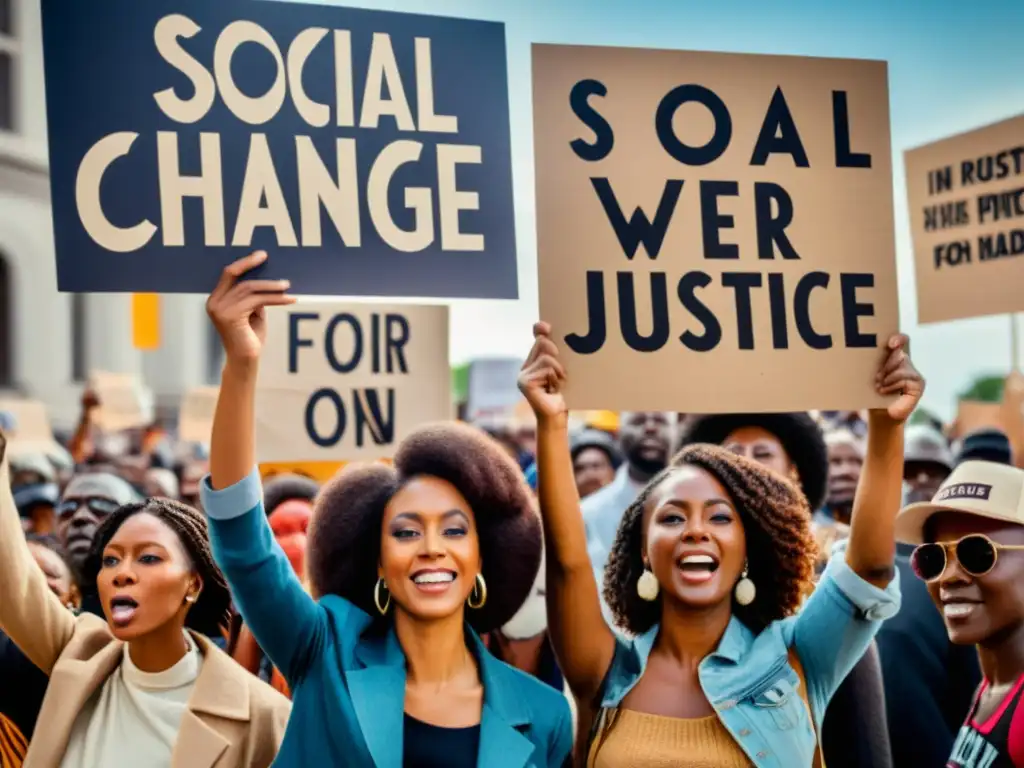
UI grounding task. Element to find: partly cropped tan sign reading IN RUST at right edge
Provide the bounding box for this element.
[904,115,1024,324]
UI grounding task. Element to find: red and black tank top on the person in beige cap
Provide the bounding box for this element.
[946,675,1024,768]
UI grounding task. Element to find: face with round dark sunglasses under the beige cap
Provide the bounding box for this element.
[928,512,1024,645]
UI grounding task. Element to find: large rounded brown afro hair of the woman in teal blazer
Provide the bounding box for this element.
[306,423,542,633]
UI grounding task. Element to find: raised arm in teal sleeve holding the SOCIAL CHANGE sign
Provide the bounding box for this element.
[201,252,326,680]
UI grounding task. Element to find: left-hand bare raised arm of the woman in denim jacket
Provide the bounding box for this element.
[519,323,615,702]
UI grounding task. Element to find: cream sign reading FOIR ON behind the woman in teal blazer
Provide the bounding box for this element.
[256,302,453,464]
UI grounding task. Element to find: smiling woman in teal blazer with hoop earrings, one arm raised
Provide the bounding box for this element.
[195,253,572,768]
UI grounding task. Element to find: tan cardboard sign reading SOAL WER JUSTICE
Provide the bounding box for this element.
[534,45,898,413]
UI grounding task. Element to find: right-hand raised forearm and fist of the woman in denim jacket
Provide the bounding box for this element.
[846,334,925,588]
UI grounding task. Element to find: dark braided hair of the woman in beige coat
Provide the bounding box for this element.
[82,499,231,637]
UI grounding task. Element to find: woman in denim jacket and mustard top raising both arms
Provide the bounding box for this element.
[519,323,924,768]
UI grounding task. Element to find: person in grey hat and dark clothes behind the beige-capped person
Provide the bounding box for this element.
[877,424,981,766]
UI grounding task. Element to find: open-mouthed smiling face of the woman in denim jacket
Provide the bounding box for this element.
[644,466,746,608]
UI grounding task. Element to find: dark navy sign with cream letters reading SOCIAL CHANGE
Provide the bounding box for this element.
[43,0,517,298]
